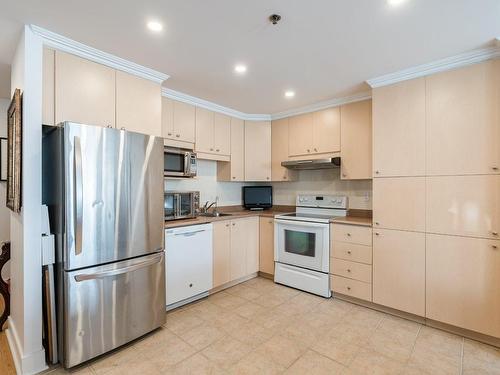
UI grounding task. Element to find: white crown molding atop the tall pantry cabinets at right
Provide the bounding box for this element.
[366,44,500,88]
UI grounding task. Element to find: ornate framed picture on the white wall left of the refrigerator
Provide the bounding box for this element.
[6,89,22,212]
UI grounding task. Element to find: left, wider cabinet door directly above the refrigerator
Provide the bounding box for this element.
[55,51,116,127]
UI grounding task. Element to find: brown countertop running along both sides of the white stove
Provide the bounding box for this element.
[165,206,372,228]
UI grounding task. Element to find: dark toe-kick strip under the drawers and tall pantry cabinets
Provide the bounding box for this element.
[333,293,500,348]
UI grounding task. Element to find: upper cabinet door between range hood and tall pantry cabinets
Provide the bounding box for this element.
[340,100,372,180]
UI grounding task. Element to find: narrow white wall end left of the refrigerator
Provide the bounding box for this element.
[7,26,47,374]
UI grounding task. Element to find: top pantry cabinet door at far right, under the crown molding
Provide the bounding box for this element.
[426,60,500,175]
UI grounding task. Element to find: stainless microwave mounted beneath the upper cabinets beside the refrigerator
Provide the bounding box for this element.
[163,147,197,178]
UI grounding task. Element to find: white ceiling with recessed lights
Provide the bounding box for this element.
[0,0,500,113]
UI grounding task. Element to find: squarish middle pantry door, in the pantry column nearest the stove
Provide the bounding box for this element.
[373,177,425,232]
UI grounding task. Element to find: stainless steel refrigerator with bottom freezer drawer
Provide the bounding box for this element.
[42,122,166,368]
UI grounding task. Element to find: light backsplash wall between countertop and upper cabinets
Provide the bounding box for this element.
[165,160,372,210]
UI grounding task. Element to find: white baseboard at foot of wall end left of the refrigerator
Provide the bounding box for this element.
[5,317,48,375]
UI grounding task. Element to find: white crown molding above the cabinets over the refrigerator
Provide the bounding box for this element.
[29,25,169,83]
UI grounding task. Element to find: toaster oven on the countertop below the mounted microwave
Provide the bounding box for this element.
[164,191,200,220]
